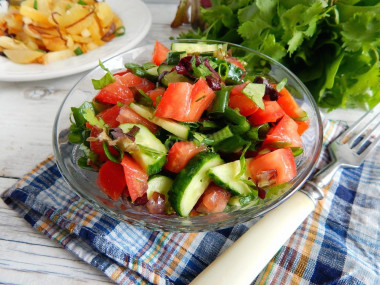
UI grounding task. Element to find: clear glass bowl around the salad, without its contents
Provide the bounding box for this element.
[53,40,322,232]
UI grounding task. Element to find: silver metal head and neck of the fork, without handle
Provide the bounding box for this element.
[301,104,380,201]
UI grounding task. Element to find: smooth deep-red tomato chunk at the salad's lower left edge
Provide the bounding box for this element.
[97,160,127,201]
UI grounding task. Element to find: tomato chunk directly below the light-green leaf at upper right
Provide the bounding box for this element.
[248,100,285,126]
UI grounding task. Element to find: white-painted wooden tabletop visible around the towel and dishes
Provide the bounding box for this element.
[0,0,364,284]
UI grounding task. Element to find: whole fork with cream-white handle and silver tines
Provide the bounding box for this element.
[191,104,380,285]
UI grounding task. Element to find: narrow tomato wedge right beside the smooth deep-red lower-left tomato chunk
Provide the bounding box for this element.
[121,154,148,202]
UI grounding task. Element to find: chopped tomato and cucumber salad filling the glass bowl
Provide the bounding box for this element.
[69,41,309,217]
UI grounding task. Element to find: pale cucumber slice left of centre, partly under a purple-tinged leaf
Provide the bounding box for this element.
[119,123,167,175]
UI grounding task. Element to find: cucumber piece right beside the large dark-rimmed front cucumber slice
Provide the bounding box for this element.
[208,158,252,196]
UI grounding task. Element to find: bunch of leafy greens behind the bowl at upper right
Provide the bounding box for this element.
[179,0,380,110]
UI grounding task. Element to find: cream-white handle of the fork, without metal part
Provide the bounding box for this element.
[190,191,315,285]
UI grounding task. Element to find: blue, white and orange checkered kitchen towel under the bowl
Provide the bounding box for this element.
[2,122,380,284]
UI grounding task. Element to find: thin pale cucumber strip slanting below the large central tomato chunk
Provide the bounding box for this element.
[129,103,190,140]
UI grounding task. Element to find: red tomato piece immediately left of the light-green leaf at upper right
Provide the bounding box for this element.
[228,83,259,117]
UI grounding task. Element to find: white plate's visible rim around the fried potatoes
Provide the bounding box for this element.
[0,0,152,81]
